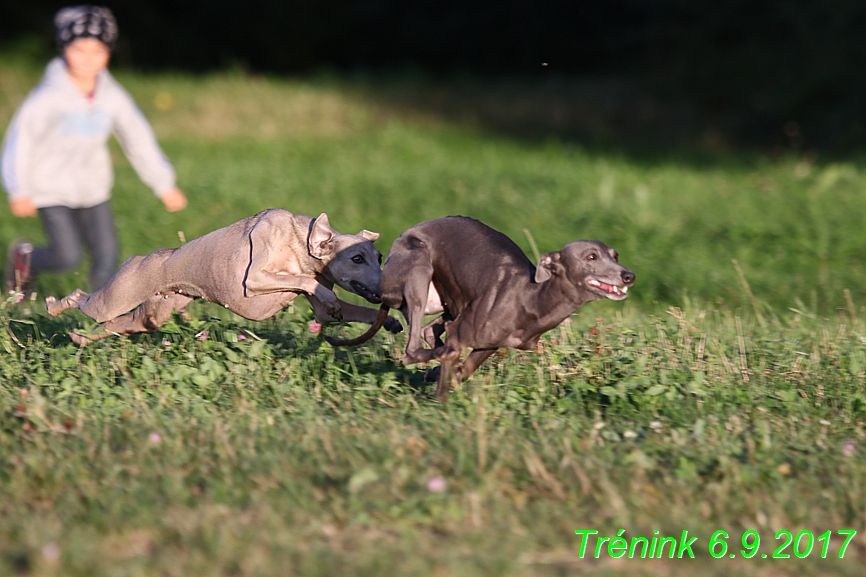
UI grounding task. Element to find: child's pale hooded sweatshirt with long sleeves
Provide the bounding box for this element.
[0,57,175,208]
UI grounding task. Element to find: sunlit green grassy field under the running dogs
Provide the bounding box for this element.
[0,57,866,577]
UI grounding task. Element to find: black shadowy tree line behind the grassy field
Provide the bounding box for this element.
[0,0,866,149]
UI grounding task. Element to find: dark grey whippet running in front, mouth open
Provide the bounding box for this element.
[325,216,634,400]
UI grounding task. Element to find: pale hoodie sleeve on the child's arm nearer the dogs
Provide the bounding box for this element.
[114,86,176,196]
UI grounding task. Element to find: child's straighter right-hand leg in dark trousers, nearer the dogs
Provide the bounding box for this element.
[74,202,120,291]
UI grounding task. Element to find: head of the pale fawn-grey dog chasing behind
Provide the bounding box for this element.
[307,213,382,304]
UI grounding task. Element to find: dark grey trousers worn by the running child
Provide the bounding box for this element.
[30,202,120,291]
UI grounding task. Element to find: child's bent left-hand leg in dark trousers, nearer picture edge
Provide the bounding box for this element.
[30,206,83,275]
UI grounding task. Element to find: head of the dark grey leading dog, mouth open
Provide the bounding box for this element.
[535,240,634,301]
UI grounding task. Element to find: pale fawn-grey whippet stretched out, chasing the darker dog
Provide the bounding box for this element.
[45,209,402,345]
